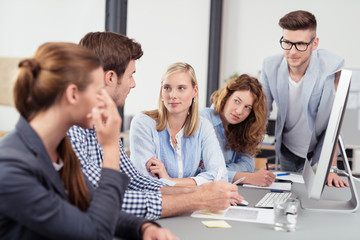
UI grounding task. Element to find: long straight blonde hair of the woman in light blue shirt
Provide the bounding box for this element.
[143,62,200,137]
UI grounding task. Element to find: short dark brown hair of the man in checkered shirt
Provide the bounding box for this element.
[79,32,143,79]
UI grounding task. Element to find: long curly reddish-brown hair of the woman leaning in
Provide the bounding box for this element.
[211,74,268,155]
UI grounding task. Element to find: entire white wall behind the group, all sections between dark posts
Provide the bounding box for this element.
[0,0,360,133]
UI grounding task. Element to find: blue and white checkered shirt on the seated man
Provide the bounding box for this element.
[67,126,163,219]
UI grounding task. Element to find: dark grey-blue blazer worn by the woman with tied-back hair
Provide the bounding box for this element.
[0,117,146,240]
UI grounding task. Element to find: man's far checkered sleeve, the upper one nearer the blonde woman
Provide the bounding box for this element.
[119,140,164,191]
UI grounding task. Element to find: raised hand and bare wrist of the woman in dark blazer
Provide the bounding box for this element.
[89,89,121,170]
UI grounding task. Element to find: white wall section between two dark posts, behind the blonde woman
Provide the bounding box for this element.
[125,0,210,115]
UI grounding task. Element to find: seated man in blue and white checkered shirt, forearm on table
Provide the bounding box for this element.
[68,32,243,219]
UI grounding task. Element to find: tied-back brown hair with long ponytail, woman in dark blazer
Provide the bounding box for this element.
[14,43,101,210]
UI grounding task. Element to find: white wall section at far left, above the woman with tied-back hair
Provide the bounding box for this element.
[0,0,105,131]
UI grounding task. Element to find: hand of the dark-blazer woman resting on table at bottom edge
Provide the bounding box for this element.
[141,222,178,240]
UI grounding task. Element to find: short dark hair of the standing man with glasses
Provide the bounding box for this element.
[279,10,317,32]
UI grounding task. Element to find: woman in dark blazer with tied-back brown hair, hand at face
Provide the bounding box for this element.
[0,43,176,239]
